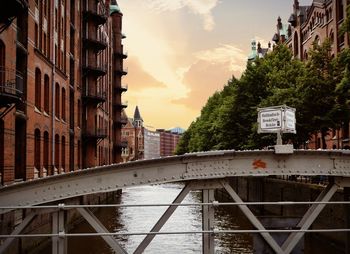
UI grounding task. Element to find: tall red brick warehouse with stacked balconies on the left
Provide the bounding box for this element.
[0,0,127,184]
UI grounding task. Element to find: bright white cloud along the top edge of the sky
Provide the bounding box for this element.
[147,0,219,31]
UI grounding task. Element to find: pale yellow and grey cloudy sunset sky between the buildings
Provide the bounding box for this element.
[117,0,312,129]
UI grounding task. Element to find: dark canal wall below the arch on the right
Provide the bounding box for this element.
[216,177,347,253]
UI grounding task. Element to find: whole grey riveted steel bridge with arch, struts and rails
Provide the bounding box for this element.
[0,146,350,254]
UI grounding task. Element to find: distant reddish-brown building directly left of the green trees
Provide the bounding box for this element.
[157,129,183,157]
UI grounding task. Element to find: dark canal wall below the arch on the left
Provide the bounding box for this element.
[0,191,121,254]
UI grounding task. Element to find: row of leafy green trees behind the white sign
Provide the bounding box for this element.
[176,41,350,154]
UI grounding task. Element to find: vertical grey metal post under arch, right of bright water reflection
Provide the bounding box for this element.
[202,189,214,254]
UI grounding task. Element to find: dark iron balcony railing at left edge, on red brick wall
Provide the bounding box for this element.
[0,66,23,98]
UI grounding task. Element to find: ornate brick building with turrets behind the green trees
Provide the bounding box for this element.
[273,0,350,149]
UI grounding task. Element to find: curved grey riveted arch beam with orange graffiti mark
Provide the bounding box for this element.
[0,150,350,206]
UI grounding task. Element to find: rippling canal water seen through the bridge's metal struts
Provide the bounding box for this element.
[68,184,253,254]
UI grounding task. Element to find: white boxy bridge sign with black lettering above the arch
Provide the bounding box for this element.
[258,105,296,133]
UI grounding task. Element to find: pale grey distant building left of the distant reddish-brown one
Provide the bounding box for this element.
[143,128,160,159]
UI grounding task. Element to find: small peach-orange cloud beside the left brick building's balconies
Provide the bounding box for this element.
[125,57,166,90]
